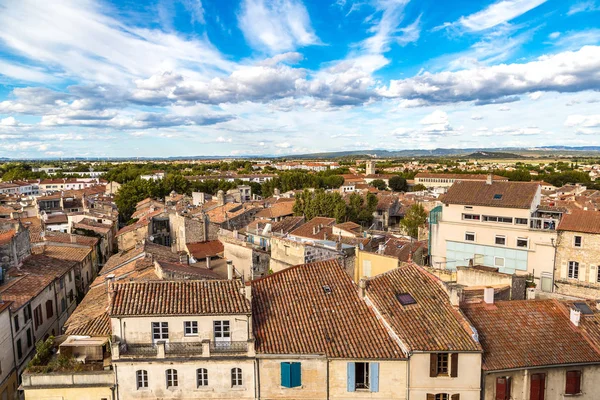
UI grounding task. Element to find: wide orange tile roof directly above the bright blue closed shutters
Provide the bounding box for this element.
[251,260,406,359]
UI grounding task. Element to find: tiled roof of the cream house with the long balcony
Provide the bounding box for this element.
[109,280,251,316]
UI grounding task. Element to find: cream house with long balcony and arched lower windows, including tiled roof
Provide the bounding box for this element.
[109,280,256,399]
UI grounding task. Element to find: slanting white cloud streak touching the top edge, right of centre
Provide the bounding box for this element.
[458,0,546,32]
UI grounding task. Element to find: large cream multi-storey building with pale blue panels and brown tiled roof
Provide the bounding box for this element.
[429,176,562,291]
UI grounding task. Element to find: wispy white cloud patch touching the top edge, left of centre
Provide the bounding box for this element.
[238,0,320,53]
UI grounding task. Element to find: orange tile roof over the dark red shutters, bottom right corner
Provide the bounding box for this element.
[463,300,600,371]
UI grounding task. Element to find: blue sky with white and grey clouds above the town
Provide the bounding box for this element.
[0,0,600,158]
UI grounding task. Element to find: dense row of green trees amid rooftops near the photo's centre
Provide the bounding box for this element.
[294,189,377,226]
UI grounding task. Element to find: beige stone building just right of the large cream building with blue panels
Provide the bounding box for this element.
[555,210,600,299]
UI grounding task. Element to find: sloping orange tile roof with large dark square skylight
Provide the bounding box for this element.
[367,263,481,351]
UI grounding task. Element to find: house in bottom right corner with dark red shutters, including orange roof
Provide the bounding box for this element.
[462,296,600,400]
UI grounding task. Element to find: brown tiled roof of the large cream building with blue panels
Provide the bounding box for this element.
[441,181,540,209]
